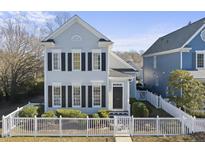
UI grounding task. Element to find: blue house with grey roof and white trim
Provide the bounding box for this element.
[143,18,205,97]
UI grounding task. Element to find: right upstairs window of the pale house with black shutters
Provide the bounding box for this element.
[92,49,101,71]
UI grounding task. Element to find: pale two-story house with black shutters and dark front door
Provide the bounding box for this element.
[42,16,136,114]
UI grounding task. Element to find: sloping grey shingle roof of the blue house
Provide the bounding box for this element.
[143,18,205,56]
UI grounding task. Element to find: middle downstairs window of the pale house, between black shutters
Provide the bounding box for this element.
[72,86,81,107]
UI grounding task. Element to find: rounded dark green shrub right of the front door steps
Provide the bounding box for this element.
[132,102,149,117]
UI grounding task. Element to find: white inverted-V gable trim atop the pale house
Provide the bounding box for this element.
[43,15,111,42]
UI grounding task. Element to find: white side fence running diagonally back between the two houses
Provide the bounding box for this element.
[136,91,205,132]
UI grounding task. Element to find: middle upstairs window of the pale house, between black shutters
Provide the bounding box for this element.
[72,49,81,71]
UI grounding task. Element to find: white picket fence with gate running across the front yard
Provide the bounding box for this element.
[2,116,190,137]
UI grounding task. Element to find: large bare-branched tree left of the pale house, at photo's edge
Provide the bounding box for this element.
[0,19,43,98]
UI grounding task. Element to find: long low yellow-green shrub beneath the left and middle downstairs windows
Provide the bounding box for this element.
[56,109,87,118]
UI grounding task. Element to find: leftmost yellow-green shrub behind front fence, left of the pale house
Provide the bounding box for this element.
[19,106,38,117]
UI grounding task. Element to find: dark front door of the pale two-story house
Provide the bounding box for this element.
[113,87,123,109]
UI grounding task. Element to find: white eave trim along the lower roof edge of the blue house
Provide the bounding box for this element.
[143,48,191,57]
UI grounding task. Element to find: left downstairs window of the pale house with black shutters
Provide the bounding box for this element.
[52,83,62,107]
